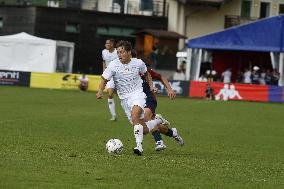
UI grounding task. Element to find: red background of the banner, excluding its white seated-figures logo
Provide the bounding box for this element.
[189,81,269,102]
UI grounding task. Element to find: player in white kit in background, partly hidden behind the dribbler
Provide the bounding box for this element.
[102,39,118,121]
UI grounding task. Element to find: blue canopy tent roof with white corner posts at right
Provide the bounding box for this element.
[187,15,284,85]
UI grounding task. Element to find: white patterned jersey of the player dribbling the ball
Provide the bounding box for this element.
[102,59,147,99]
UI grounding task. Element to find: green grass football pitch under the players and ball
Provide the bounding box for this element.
[0,86,284,189]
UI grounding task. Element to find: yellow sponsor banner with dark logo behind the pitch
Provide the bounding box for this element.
[30,72,101,91]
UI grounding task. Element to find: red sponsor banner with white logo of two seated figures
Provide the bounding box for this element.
[189,81,269,102]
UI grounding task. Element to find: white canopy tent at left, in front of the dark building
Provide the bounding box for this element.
[0,32,74,73]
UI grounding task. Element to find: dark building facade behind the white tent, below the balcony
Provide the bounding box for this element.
[0,1,168,74]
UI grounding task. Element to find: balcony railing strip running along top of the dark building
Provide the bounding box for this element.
[0,0,168,16]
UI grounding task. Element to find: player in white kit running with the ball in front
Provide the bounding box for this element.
[96,41,163,155]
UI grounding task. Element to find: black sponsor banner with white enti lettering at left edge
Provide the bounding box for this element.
[0,70,31,87]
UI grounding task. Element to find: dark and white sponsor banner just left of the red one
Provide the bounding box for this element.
[153,80,189,96]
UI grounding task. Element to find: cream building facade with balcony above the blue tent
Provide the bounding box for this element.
[168,0,284,48]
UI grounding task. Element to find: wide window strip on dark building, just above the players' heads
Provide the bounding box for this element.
[97,26,135,37]
